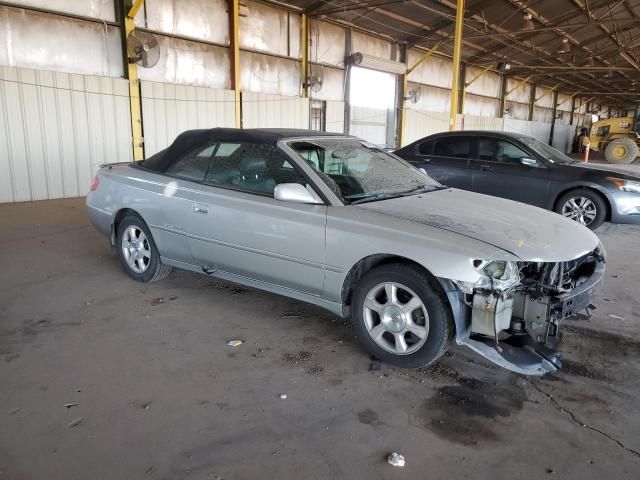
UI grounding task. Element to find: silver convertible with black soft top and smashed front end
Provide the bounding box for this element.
[87,129,605,375]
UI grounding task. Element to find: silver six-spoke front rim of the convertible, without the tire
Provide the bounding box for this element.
[363,282,429,355]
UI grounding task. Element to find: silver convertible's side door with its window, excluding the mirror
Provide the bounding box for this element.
[184,142,327,295]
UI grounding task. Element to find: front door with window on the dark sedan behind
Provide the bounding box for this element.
[470,137,549,207]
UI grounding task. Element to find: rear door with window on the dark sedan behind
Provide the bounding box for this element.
[410,135,473,190]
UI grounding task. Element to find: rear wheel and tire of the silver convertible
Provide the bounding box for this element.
[116,215,171,282]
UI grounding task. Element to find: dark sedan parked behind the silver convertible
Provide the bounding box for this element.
[395,131,640,229]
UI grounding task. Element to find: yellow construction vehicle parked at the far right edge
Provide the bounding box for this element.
[589,105,640,164]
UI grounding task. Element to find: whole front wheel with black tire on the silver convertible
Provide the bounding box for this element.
[352,264,453,368]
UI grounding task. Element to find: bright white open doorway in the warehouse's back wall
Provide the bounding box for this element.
[349,67,396,147]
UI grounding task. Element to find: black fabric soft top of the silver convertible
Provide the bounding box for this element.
[138,128,346,172]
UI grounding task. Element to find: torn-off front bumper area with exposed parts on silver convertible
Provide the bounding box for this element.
[441,249,605,375]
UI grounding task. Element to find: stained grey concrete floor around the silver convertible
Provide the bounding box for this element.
[0,199,640,480]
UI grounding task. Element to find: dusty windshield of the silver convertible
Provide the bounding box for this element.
[289,138,443,203]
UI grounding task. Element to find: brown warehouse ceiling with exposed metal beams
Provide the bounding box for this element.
[287,0,640,105]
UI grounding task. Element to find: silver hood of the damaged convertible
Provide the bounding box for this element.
[356,188,599,262]
